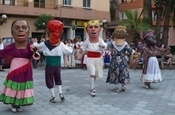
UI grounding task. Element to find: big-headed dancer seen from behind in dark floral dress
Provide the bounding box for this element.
[106,25,132,92]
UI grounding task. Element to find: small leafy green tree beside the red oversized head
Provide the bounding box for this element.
[34,14,54,30]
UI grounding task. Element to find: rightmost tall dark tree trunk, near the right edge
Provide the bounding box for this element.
[162,0,171,46]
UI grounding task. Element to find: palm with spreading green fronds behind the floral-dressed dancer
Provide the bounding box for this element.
[119,10,151,45]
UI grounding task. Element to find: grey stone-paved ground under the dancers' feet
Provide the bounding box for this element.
[0,67,175,115]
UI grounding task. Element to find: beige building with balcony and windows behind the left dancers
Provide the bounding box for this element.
[0,0,110,40]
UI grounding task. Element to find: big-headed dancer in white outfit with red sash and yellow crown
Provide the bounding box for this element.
[82,20,107,96]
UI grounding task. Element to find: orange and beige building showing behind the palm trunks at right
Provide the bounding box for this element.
[117,0,175,46]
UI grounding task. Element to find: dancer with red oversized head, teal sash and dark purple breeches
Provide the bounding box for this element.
[31,20,73,103]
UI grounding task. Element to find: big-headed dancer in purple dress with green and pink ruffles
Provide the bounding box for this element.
[0,20,39,112]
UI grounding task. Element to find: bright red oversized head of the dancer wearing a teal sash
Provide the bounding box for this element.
[47,20,64,45]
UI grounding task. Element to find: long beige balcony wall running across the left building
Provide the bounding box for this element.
[0,0,110,20]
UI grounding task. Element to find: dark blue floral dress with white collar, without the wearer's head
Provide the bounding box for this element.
[106,42,132,84]
